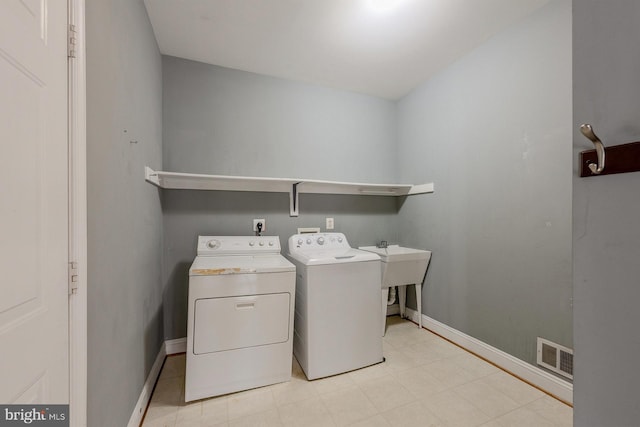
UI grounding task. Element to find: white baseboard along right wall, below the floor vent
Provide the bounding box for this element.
[405,308,573,404]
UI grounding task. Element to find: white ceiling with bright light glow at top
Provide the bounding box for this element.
[144,0,549,99]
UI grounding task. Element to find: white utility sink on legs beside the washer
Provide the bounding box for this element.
[359,245,431,335]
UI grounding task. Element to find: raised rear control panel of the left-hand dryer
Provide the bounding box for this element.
[197,236,280,256]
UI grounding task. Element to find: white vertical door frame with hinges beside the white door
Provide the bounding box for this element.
[67,0,87,427]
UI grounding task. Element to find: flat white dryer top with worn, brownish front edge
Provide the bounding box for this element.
[189,255,296,276]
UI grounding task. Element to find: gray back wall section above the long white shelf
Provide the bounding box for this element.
[162,56,396,183]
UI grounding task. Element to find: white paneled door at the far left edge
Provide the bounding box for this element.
[0,0,69,404]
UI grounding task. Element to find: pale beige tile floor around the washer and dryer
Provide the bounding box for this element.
[143,316,573,427]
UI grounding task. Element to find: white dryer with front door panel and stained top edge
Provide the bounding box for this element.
[185,236,295,402]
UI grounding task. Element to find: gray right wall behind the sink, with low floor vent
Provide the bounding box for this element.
[398,0,572,363]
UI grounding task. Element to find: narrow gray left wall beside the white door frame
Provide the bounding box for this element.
[86,0,163,426]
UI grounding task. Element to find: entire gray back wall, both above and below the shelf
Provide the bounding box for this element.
[162,57,397,339]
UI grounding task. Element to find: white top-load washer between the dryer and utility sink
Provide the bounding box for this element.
[288,233,383,380]
